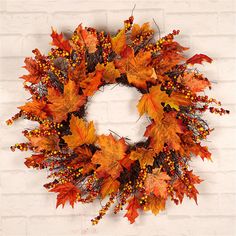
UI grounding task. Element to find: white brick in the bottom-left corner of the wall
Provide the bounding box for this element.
[2,217,27,236]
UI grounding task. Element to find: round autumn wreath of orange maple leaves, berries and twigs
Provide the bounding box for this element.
[7,16,229,224]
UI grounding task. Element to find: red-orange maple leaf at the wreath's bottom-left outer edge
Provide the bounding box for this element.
[50,182,80,208]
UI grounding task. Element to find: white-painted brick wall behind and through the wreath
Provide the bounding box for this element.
[0,0,236,236]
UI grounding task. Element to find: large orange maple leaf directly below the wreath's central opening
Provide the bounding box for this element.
[92,134,127,179]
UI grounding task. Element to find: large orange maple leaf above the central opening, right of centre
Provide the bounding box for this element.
[116,47,156,89]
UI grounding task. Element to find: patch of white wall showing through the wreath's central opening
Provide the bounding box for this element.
[86,84,150,143]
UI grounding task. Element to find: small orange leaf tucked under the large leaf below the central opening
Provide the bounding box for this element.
[100,176,120,199]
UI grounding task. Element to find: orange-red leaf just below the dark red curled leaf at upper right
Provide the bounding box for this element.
[178,72,211,93]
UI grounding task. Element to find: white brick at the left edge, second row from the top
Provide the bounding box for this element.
[0,13,51,35]
